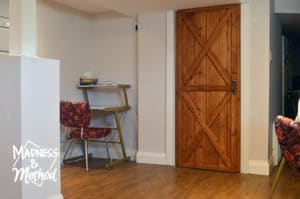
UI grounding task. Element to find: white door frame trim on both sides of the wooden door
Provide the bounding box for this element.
[166,2,250,173]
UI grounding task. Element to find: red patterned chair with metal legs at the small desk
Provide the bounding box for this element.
[60,101,111,171]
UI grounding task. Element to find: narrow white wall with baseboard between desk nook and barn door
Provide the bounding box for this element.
[137,13,167,164]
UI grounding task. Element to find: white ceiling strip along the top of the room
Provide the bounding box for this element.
[50,0,241,16]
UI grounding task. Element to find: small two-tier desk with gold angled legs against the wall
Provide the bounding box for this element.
[77,84,131,169]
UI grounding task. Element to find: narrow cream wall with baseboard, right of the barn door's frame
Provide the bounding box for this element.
[241,0,270,175]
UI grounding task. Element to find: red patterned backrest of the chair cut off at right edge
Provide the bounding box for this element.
[275,116,300,176]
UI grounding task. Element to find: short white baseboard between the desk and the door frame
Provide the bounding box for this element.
[136,151,166,165]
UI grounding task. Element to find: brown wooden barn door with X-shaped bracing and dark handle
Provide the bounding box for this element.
[176,5,240,172]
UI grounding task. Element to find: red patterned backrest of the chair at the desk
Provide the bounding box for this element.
[60,101,91,128]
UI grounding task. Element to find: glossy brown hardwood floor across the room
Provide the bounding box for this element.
[61,160,300,199]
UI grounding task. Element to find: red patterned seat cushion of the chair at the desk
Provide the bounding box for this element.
[71,128,111,139]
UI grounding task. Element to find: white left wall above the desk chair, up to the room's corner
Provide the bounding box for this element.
[37,0,93,100]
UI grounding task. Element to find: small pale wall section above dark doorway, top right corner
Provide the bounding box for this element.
[275,0,300,13]
